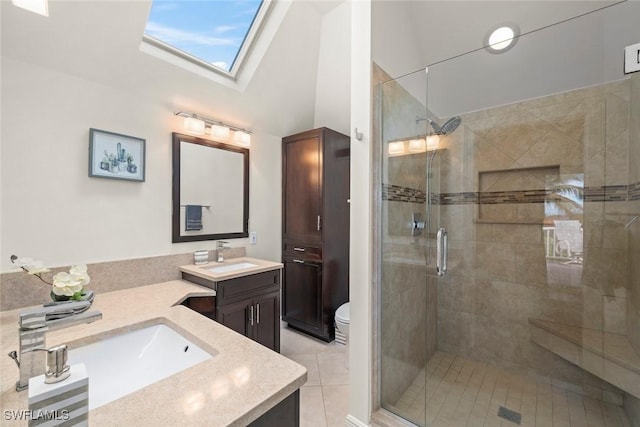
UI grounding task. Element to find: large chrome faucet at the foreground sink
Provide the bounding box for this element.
[9,301,102,391]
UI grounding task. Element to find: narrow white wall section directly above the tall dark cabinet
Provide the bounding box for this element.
[314,2,351,135]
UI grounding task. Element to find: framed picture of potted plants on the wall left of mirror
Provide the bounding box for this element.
[89,128,146,182]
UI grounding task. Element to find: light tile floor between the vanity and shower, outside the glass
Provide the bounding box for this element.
[280,327,349,427]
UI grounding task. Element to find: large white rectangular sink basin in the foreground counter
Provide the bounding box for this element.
[69,325,213,410]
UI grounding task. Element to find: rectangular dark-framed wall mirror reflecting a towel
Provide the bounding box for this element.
[172,133,249,243]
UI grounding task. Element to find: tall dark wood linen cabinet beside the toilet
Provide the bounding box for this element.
[282,128,350,342]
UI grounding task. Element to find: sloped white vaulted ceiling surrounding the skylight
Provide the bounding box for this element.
[0,0,339,135]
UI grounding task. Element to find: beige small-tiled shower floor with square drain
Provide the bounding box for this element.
[394,352,630,427]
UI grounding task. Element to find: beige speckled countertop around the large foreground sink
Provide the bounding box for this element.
[0,282,307,426]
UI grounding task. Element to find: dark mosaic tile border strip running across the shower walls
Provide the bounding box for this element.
[382,182,640,205]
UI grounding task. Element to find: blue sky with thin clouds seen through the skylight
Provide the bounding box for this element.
[145,0,262,71]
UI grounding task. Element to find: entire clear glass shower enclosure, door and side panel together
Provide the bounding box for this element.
[379,2,640,426]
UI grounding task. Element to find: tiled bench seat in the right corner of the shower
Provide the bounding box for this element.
[529,319,640,398]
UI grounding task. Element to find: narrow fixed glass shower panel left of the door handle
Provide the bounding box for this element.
[379,72,439,424]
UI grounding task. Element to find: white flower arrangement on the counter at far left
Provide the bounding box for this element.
[11,255,91,301]
